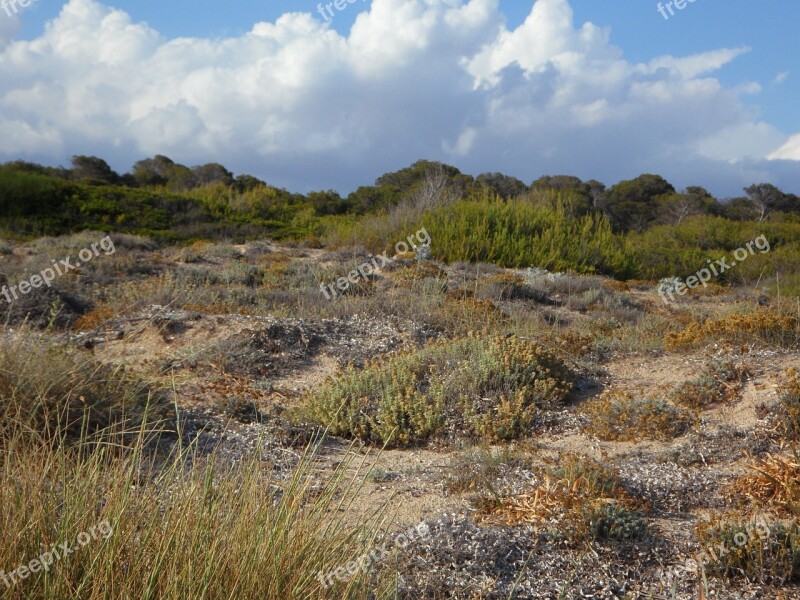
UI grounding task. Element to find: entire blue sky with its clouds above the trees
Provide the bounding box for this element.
[0,0,800,198]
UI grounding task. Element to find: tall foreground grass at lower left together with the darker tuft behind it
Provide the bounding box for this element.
[0,332,398,600]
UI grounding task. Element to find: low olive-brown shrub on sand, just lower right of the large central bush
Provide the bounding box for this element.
[581,390,694,442]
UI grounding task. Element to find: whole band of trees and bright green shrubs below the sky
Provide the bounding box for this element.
[0,156,800,295]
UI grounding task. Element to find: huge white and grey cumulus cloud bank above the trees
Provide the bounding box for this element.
[0,0,800,191]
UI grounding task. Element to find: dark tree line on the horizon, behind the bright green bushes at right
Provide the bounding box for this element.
[0,155,800,237]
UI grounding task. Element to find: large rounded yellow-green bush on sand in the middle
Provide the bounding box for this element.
[306,337,574,446]
